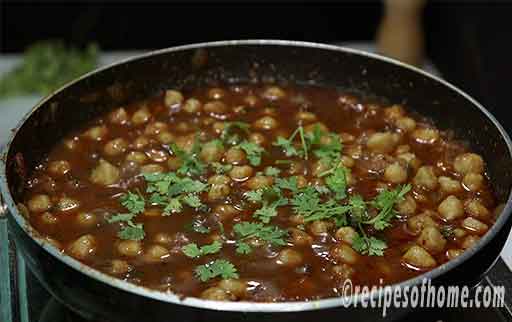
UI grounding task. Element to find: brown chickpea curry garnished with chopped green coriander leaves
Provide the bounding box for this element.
[20,85,499,302]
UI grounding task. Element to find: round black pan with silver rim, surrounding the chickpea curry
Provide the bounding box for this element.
[0,40,512,322]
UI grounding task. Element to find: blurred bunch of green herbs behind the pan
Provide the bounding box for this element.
[0,41,98,97]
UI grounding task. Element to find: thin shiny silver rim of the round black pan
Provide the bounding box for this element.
[0,39,512,313]
